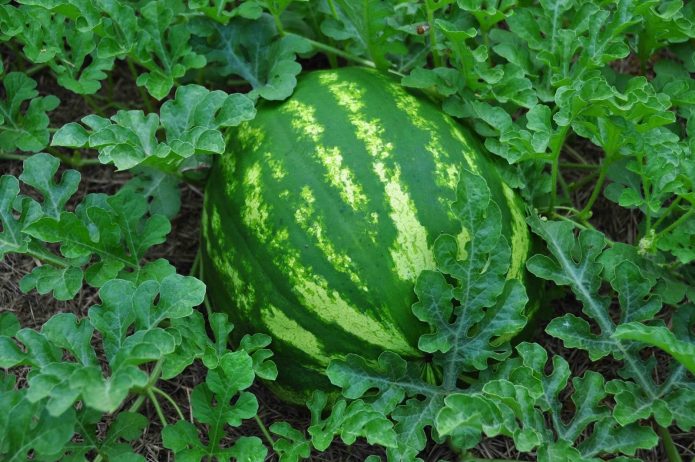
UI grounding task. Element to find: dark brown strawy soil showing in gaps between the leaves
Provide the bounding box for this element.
[0,55,695,462]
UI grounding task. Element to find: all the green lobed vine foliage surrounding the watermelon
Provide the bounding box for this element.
[0,0,695,462]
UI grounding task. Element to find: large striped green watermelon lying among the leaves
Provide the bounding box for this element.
[202,68,530,402]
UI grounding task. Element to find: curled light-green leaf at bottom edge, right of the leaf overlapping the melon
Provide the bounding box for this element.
[437,343,657,462]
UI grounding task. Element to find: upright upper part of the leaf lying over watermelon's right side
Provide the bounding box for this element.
[413,171,528,378]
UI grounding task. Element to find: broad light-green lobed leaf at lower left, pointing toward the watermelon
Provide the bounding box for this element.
[6,274,207,416]
